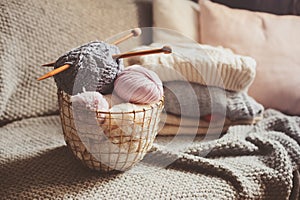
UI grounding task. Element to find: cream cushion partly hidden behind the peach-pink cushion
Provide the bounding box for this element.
[153,0,199,42]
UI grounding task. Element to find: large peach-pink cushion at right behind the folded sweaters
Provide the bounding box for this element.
[200,1,300,115]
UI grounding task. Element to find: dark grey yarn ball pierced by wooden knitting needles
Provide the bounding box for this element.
[54,41,124,95]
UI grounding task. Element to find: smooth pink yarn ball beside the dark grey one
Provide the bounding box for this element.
[114,65,163,104]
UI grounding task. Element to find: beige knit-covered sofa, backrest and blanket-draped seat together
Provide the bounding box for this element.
[0,0,300,199]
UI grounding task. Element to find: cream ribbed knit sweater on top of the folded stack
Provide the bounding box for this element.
[128,43,256,91]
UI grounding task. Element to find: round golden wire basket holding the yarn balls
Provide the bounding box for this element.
[58,91,163,171]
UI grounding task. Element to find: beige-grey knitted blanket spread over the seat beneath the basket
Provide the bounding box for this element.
[0,110,300,199]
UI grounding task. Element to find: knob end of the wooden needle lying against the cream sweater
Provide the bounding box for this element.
[112,46,172,59]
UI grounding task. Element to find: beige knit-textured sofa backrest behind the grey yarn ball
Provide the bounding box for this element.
[0,0,142,125]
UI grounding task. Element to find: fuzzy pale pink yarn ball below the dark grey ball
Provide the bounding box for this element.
[70,91,109,124]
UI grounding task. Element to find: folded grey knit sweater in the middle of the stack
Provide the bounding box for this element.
[164,81,264,120]
